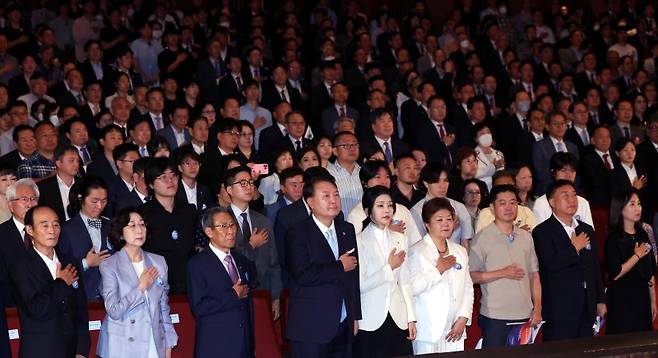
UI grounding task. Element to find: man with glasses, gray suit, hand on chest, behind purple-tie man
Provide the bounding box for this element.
[224,167,282,320]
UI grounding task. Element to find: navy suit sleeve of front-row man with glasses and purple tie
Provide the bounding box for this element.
[187,257,241,319]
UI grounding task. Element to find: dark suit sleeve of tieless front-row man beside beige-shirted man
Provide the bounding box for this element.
[532,227,580,272]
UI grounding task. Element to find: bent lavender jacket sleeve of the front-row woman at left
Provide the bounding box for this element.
[100,261,146,320]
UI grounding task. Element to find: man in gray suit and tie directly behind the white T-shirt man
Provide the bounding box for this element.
[532,112,580,195]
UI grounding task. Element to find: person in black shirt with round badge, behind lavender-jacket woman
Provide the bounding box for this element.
[138,158,198,294]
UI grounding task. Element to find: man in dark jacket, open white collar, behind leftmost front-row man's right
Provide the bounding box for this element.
[37,144,81,222]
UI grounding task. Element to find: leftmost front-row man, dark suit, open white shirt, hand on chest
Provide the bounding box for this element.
[12,206,90,358]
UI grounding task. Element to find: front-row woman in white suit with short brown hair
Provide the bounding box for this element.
[409,198,473,354]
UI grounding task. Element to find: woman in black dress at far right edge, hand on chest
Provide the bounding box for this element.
[605,189,658,334]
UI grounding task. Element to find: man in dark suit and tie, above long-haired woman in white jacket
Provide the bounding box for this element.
[361,108,411,163]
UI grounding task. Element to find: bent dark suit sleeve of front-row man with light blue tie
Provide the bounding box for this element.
[286,225,343,286]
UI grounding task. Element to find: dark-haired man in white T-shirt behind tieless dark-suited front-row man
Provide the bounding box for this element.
[532,153,596,229]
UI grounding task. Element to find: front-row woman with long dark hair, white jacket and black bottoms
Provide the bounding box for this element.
[353,186,416,358]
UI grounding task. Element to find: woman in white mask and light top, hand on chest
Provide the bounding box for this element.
[471,123,505,190]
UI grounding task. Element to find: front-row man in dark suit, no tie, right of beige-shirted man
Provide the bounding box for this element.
[532,180,606,341]
